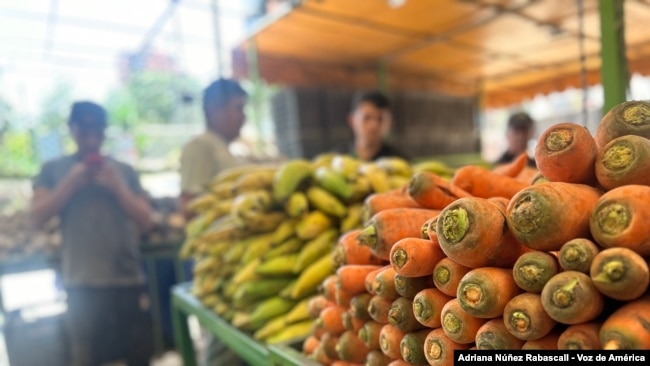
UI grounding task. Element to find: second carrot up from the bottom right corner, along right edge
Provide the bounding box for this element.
[589,248,650,301]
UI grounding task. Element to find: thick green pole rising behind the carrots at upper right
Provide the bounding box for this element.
[598,0,628,114]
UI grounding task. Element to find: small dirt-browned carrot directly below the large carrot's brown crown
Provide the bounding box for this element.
[512,251,559,293]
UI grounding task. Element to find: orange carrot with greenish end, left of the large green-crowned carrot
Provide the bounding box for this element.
[359,208,440,260]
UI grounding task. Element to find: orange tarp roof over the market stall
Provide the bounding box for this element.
[233,0,650,107]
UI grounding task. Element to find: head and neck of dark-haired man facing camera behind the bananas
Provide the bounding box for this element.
[347,91,403,161]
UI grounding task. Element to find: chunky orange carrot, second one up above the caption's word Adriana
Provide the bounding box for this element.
[457,267,521,319]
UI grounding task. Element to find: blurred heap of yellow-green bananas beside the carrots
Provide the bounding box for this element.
[181,154,436,343]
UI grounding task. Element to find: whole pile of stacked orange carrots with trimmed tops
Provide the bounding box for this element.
[304,102,650,366]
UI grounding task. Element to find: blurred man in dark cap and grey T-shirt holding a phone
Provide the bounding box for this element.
[31,101,153,366]
